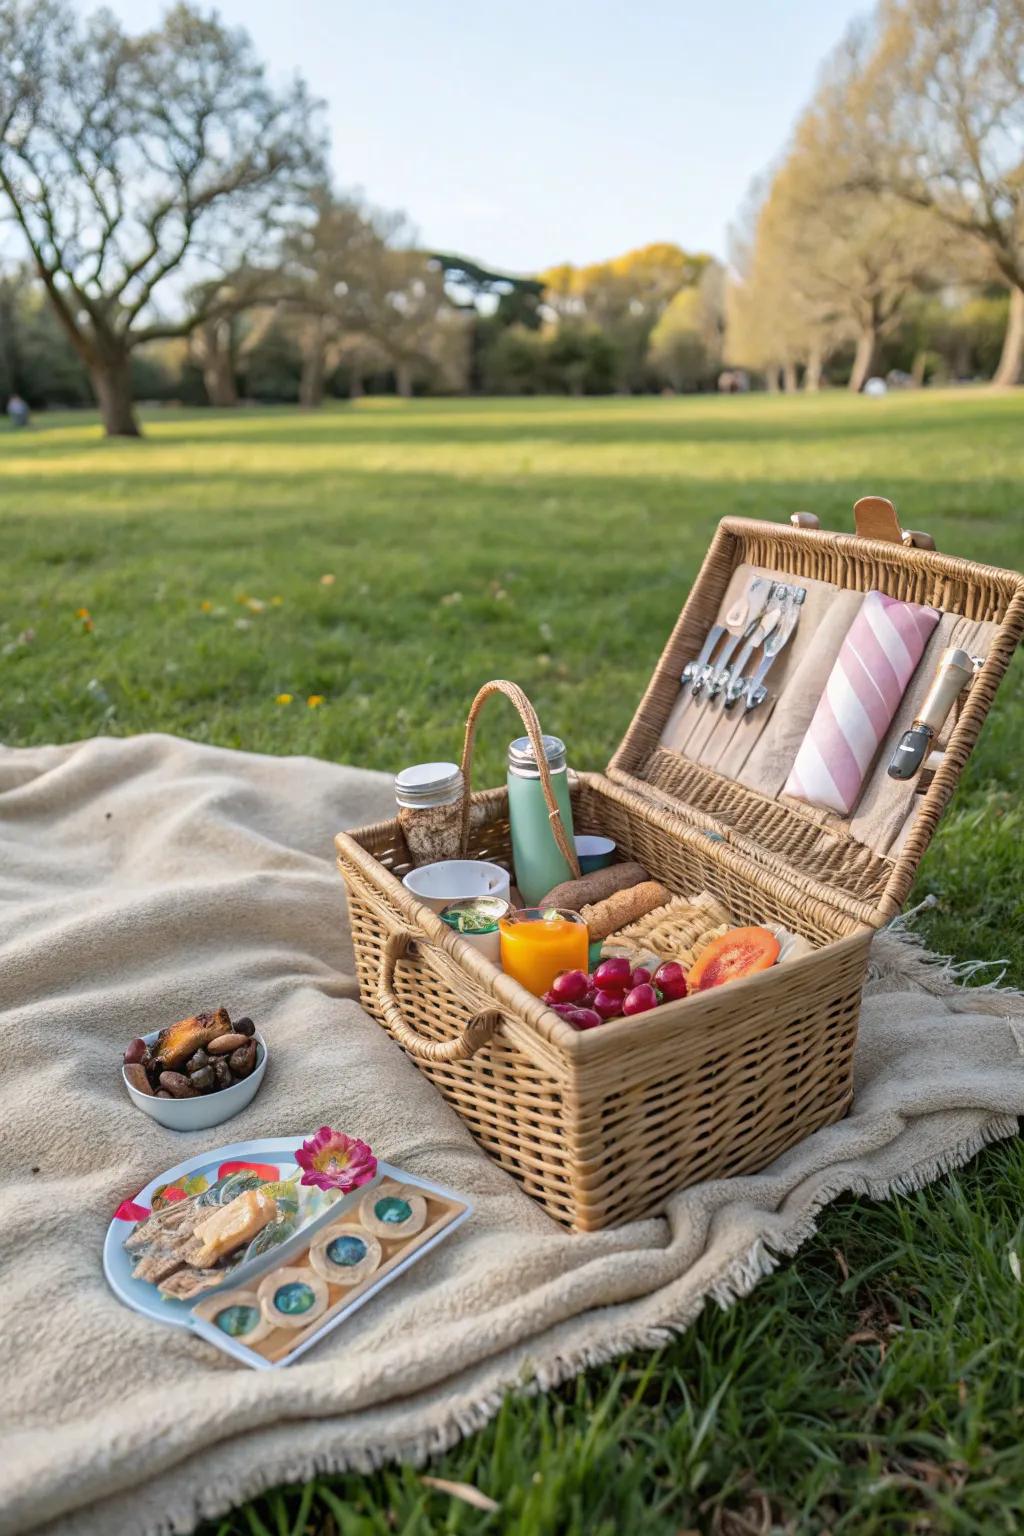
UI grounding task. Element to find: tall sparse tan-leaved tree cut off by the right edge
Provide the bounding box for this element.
[841,0,1024,384]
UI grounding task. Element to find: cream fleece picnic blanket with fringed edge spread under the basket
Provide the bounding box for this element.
[0,736,1024,1536]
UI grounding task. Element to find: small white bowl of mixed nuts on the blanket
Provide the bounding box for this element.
[121,1008,267,1130]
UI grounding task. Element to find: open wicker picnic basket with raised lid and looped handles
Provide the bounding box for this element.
[336,498,1024,1230]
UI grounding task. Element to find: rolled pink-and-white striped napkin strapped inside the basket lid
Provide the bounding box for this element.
[783,591,940,814]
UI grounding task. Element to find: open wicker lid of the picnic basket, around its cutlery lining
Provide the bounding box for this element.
[608,496,1024,926]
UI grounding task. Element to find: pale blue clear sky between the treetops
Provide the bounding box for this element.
[112,0,866,272]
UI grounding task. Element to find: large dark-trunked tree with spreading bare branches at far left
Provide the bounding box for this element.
[0,0,324,436]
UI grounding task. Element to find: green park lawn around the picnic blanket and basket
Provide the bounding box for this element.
[0,392,1024,1536]
